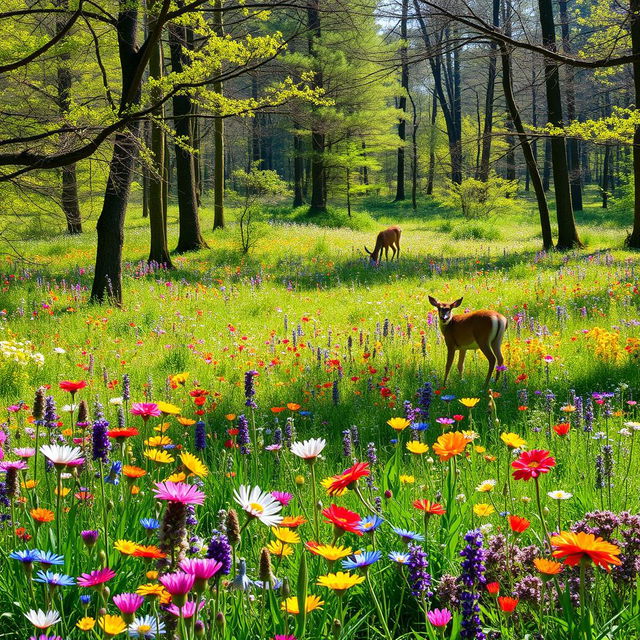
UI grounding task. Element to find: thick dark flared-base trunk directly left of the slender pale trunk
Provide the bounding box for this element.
[169,18,207,253]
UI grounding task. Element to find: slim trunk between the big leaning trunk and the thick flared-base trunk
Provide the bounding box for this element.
[147,2,172,267]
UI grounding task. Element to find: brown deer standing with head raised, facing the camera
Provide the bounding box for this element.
[429,296,507,387]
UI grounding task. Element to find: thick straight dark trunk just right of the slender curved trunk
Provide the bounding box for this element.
[538,0,582,250]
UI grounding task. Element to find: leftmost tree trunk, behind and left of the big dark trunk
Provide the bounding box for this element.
[56,0,82,235]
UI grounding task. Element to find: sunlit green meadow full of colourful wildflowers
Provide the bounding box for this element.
[0,192,640,640]
